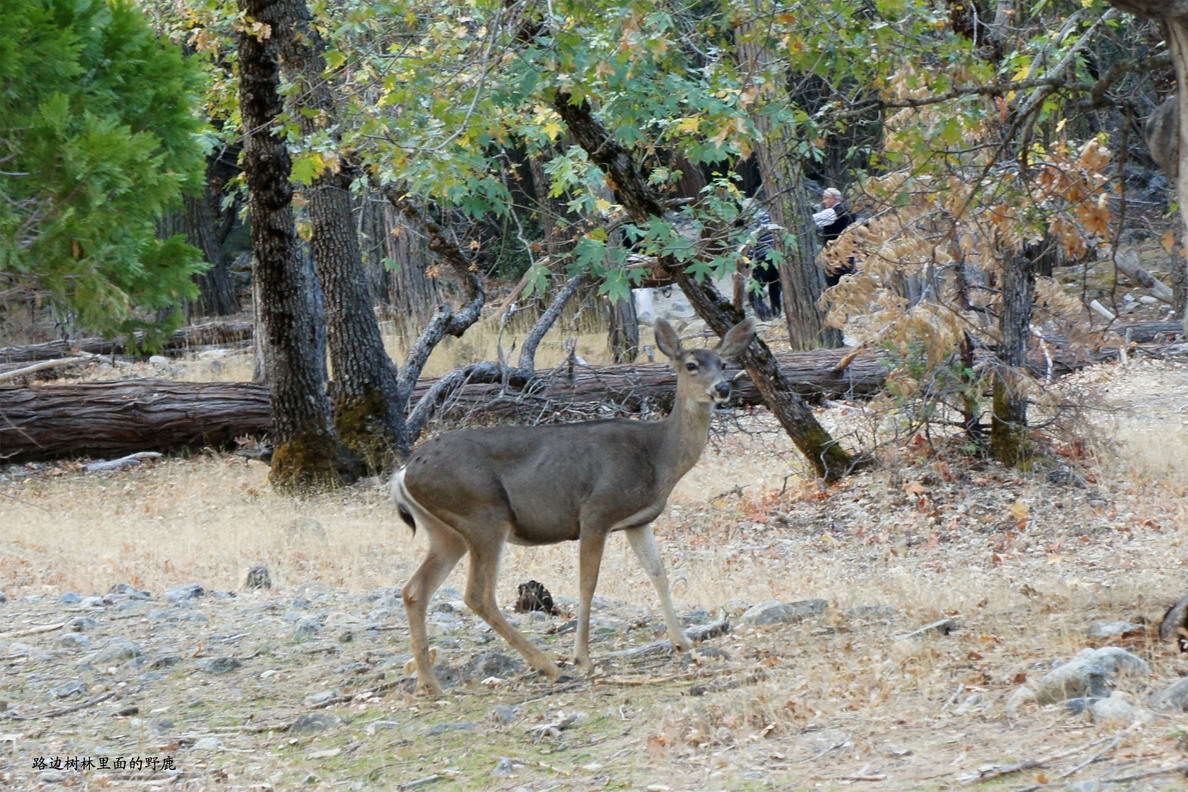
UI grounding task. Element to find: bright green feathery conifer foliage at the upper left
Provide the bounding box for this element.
[0,0,204,334]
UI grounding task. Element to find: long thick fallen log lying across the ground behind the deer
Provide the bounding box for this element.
[0,344,1183,462]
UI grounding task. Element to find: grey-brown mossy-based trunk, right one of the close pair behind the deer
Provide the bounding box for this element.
[272,0,411,465]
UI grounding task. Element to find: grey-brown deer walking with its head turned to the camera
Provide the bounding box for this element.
[391,318,756,696]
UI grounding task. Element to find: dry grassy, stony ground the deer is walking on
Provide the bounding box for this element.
[0,349,1188,792]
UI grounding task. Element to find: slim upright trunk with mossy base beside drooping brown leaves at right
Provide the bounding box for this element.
[990,246,1036,467]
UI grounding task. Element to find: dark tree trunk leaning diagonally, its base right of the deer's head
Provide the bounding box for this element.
[552,91,855,482]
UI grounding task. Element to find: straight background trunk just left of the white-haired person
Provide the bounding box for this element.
[738,7,842,349]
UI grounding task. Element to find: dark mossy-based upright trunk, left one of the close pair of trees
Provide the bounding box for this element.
[239,0,352,490]
